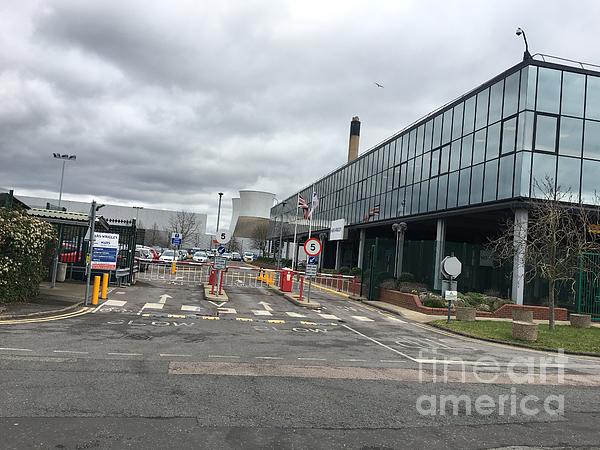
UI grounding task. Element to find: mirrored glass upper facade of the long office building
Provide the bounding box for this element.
[271,59,600,306]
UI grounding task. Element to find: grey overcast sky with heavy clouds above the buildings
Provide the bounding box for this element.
[0,0,600,229]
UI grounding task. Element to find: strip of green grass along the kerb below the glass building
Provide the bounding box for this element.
[431,320,600,356]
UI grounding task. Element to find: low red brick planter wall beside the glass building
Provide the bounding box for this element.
[379,289,568,320]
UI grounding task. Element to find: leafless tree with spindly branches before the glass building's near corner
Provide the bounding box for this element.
[489,177,600,329]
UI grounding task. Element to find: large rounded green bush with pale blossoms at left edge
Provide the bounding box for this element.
[0,208,56,303]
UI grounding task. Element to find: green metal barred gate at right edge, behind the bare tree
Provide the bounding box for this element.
[577,253,600,322]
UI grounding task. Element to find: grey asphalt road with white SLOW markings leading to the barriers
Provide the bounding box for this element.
[0,272,600,449]
